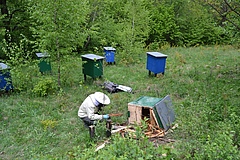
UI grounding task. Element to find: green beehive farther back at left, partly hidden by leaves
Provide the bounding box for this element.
[36,53,52,73]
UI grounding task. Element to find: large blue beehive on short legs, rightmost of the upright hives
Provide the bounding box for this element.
[147,52,167,76]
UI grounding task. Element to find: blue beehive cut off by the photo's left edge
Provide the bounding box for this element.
[0,63,13,91]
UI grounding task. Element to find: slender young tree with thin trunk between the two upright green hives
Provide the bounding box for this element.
[29,0,89,87]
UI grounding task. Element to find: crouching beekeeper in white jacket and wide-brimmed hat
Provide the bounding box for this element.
[78,92,110,127]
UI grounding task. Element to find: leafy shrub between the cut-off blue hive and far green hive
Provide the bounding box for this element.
[2,35,36,92]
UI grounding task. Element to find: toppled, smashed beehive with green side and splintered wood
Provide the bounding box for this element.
[128,95,175,130]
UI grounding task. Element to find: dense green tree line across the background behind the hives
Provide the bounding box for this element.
[0,0,239,63]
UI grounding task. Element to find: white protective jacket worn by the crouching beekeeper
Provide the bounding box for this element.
[78,94,103,120]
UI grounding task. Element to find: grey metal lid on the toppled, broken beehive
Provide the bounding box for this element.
[155,95,175,130]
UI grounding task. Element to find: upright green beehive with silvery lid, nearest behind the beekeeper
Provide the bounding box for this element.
[82,54,104,80]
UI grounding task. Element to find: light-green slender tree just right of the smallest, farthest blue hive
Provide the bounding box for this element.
[111,0,149,64]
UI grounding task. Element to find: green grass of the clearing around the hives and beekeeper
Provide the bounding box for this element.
[0,46,240,159]
